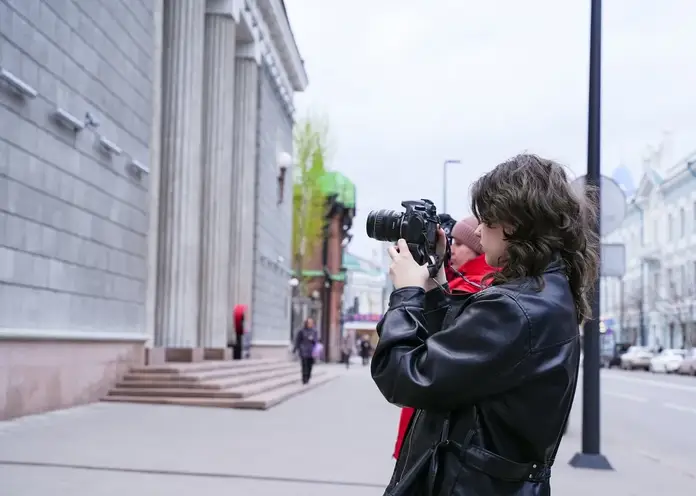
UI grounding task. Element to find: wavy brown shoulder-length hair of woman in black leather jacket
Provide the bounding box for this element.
[471,154,599,322]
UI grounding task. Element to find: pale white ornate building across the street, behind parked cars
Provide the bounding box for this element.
[601,154,696,348]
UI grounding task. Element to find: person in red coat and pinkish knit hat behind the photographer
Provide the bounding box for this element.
[393,216,496,458]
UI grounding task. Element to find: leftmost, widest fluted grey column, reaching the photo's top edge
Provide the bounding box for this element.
[157,0,205,348]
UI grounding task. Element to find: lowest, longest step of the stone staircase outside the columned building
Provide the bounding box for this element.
[102,371,340,410]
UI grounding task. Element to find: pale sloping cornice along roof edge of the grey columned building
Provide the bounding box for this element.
[257,0,309,91]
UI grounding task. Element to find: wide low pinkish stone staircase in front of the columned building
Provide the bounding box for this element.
[102,359,339,410]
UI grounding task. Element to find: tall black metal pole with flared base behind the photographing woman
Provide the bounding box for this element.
[570,0,612,470]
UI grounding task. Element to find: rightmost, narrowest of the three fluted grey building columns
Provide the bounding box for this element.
[230,43,260,320]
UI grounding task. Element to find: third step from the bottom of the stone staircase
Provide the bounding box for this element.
[116,363,299,391]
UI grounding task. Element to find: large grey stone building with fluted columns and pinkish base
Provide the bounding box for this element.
[0,0,307,418]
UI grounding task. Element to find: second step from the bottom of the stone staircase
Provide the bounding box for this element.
[109,369,300,398]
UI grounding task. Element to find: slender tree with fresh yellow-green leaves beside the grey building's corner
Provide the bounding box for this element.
[292,119,327,296]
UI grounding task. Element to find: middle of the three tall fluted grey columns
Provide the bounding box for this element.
[199,13,236,348]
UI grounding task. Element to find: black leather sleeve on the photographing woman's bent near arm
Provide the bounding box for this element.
[371,288,530,411]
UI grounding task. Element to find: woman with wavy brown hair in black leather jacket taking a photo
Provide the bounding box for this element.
[372,155,598,496]
